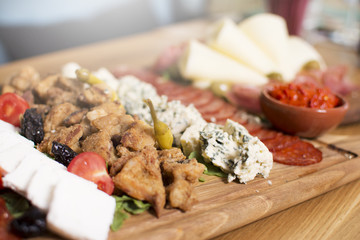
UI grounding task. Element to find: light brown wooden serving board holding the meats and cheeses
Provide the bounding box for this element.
[0,20,360,239]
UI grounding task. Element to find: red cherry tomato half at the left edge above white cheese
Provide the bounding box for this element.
[0,93,29,127]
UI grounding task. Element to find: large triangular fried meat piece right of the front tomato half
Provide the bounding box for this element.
[113,146,165,216]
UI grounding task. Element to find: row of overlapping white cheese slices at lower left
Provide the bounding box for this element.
[0,120,116,240]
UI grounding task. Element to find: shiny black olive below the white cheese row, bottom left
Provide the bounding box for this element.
[10,207,46,238]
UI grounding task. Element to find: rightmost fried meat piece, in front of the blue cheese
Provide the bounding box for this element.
[161,159,205,211]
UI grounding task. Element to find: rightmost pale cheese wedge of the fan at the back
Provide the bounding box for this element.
[284,36,326,81]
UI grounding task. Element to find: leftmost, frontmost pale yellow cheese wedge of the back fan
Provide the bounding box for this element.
[179,40,268,86]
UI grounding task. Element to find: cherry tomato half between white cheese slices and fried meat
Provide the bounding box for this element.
[67,152,114,195]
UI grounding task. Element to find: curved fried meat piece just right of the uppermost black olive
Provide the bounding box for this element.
[44,103,78,132]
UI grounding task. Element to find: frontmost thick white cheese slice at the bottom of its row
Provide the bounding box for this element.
[46,176,116,240]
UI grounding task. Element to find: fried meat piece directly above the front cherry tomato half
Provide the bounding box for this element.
[82,131,116,165]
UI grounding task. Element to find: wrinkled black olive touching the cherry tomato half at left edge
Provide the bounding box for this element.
[20,108,44,144]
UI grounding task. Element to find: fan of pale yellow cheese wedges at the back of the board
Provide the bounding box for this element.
[179,13,325,87]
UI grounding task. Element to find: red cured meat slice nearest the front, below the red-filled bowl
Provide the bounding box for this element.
[272,141,322,166]
